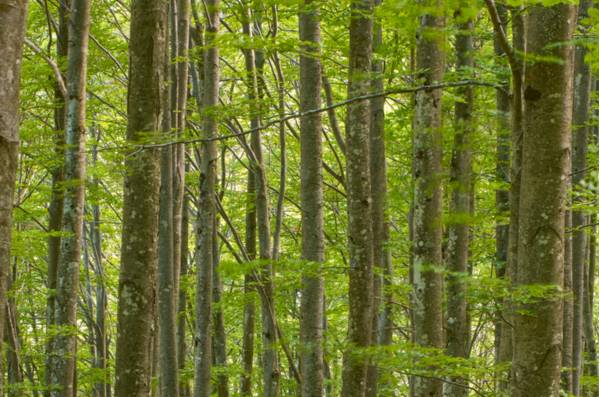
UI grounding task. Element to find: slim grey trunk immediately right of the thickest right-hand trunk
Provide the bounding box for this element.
[563,0,592,396]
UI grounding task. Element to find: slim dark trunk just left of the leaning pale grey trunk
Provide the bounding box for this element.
[44,0,69,397]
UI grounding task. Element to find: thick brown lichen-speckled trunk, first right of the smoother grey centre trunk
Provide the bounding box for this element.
[342,0,373,397]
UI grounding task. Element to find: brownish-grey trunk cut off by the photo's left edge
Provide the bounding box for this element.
[0,0,27,395]
